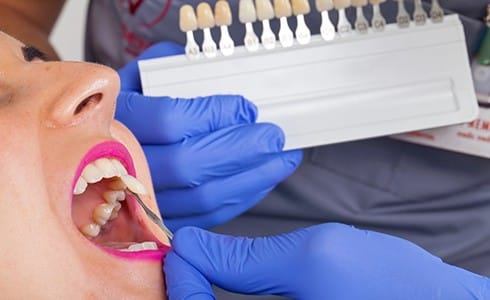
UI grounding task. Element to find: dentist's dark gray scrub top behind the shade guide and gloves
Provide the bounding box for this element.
[86,0,490,299]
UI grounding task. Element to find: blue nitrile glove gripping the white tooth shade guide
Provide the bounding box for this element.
[116,43,302,230]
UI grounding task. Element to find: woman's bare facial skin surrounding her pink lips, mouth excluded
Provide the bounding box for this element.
[0,33,168,299]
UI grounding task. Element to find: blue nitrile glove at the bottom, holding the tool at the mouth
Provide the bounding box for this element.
[164,223,490,300]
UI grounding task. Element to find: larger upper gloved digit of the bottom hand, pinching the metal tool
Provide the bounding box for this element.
[172,227,302,295]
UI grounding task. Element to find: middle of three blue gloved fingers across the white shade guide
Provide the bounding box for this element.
[147,123,290,191]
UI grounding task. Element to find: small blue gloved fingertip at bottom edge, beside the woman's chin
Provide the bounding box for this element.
[163,251,216,300]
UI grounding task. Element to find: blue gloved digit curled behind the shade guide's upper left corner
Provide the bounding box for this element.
[118,42,184,92]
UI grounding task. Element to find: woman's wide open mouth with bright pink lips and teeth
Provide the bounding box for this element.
[72,142,169,258]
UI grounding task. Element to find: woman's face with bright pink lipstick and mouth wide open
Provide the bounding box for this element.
[0,33,168,299]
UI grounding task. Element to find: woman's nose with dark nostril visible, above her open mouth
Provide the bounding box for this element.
[40,62,119,128]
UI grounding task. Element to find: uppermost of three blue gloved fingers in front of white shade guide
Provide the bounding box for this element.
[116,92,257,144]
